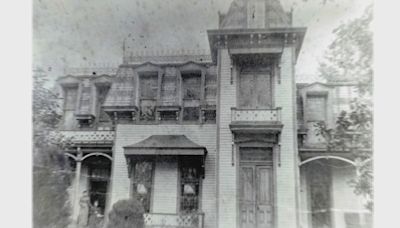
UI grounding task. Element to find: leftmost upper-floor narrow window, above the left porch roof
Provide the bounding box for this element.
[64,86,78,130]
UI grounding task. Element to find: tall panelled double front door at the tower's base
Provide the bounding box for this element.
[239,163,273,228]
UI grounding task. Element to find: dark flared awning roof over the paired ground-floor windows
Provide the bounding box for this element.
[124,135,207,156]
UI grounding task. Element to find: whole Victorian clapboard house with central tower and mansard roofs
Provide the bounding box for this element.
[58,0,370,228]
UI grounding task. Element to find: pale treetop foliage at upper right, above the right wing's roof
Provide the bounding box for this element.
[319,6,373,92]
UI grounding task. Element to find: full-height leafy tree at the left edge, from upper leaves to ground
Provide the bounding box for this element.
[32,69,70,228]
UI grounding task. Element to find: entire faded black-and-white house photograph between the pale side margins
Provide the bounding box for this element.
[31,0,374,228]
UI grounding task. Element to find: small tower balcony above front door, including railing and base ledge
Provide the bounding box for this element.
[230,107,283,132]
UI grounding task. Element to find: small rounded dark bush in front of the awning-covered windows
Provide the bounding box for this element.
[107,198,144,228]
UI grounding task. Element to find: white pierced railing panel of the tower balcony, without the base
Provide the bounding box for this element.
[232,108,281,122]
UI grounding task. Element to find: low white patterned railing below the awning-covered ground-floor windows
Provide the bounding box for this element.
[144,213,204,228]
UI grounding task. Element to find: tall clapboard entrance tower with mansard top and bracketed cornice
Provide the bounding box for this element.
[208,0,306,228]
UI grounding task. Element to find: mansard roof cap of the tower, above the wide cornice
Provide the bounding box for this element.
[220,0,291,29]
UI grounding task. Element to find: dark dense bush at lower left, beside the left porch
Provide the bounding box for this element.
[32,146,71,228]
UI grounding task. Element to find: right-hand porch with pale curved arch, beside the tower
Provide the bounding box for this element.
[300,151,372,228]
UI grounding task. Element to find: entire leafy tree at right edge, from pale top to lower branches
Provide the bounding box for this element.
[318,6,373,210]
